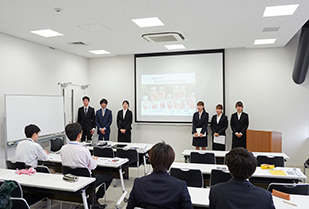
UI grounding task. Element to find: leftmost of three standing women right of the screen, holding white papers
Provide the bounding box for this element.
[192,101,209,150]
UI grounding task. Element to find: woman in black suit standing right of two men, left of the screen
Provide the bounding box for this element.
[117,100,132,142]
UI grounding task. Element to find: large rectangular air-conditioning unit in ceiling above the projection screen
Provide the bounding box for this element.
[142,32,185,43]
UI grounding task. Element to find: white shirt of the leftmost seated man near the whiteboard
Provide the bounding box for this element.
[15,139,49,167]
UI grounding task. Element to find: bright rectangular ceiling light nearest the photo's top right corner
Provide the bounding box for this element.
[263,4,299,17]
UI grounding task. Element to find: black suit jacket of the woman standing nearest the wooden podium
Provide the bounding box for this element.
[231,112,249,136]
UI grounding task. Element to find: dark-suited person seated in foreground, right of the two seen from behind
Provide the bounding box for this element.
[209,147,275,209]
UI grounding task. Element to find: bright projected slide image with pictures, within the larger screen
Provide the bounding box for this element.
[141,73,195,116]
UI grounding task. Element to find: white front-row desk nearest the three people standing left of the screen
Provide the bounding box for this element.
[84,141,154,175]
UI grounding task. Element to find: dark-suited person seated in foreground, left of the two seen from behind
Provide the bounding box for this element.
[127,142,193,209]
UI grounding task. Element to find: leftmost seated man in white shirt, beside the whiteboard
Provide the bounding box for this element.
[15,124,49,167]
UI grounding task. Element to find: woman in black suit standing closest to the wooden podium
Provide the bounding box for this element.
[231,102,249,148]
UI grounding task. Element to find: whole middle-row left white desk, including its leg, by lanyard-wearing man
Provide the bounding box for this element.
[48,153,129,207]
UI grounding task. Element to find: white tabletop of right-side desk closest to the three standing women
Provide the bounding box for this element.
[181,149,290,160]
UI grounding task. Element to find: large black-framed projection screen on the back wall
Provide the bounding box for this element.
[135,51,224,123]
